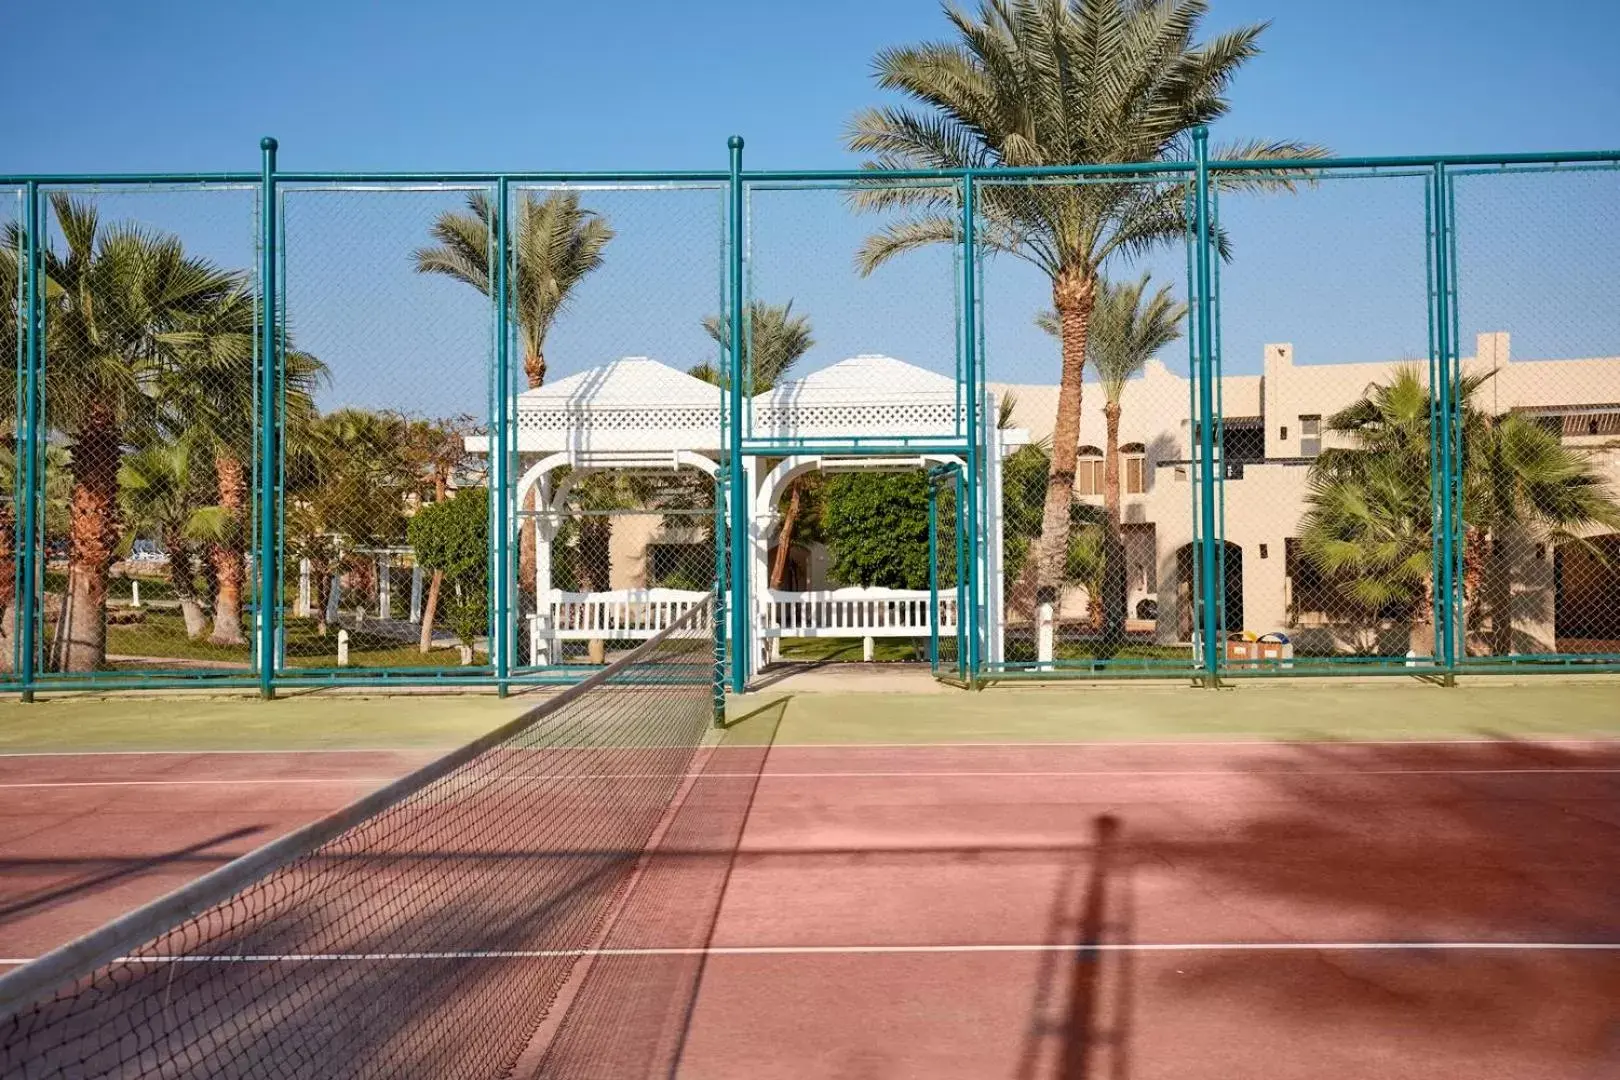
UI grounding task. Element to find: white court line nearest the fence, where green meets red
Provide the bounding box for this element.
[0,732,1620,761]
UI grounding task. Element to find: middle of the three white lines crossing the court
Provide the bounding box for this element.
[0,767,1620,790]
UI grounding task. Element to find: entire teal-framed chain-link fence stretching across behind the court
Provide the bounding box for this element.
[0,141,1620,693]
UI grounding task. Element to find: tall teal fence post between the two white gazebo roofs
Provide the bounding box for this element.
[726,134,753,693]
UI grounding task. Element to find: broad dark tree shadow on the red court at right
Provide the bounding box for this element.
[1101,740,1620,1080]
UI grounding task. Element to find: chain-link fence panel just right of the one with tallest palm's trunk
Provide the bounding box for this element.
[1212,170,1443,672]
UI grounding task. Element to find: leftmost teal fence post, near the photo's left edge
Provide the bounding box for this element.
[15,180,45,701]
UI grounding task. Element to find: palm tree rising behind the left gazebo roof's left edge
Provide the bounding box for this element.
[415,191,614,612]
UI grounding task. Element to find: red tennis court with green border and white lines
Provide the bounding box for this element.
[0,660,1620,1080]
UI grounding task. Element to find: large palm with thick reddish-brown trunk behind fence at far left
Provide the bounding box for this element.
[19,193,241,672]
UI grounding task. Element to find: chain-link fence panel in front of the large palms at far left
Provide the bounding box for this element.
[32,185,261,678]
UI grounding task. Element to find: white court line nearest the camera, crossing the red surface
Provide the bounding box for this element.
[0,941,1620,965]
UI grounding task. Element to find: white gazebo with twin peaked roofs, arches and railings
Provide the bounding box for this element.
[467,356,1027,675]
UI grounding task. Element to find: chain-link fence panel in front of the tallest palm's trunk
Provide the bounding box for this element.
[977,175,1197,672]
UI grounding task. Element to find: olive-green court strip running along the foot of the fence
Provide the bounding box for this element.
[0,678,1620,753]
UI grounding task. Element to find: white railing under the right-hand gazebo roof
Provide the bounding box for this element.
[760,588,956,638]
